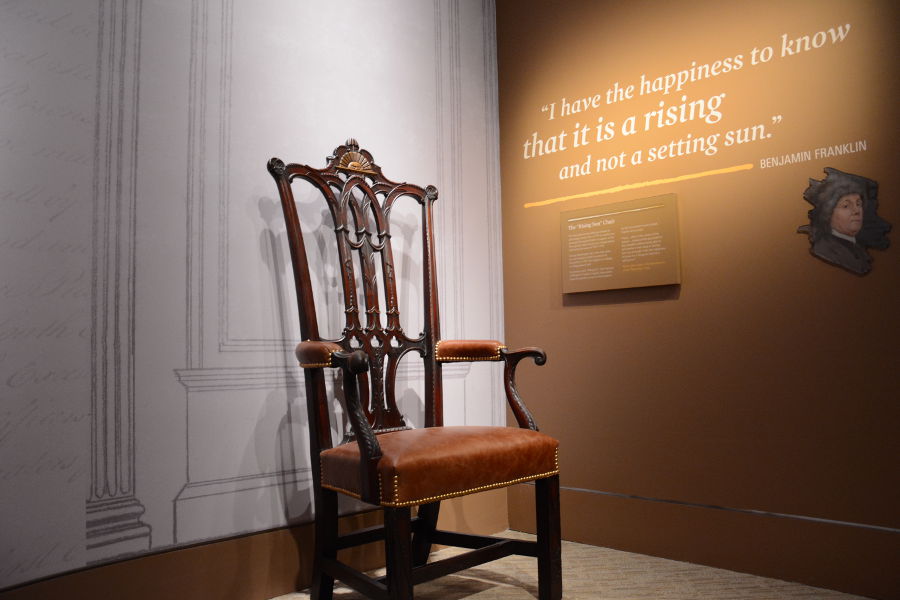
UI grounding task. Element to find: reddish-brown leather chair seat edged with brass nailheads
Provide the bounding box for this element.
[321,427,559,506]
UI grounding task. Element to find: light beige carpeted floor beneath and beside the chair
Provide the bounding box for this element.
[274,531,863,600]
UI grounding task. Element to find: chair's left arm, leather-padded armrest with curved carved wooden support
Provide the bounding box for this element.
[295,341,382,504]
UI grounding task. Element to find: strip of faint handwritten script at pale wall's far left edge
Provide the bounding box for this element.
[0,1,97,588]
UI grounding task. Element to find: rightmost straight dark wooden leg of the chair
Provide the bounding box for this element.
[534,475,562,600]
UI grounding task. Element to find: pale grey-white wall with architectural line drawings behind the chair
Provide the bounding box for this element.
[0,0,504,588]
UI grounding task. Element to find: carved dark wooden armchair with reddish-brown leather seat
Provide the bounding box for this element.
[268,139,562,600]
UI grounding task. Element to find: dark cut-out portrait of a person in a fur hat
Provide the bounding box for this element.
[797,167,891,275]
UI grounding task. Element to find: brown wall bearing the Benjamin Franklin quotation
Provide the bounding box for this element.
[497,0,900,597]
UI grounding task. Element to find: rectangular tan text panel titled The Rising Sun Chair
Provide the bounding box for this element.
[560,194,681,294]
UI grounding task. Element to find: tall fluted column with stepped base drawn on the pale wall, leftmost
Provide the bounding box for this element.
[86,0,151,563]
